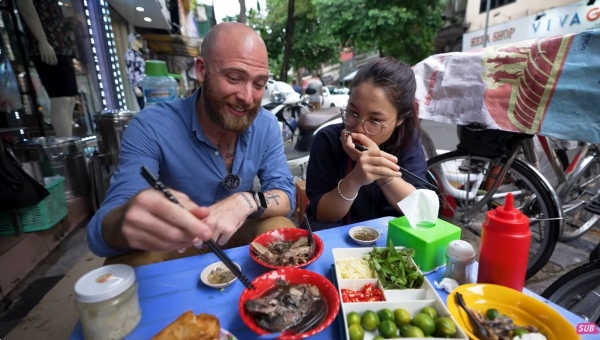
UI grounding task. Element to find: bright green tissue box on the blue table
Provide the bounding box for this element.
[386,216,461,273]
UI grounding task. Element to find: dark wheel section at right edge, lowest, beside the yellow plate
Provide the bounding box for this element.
[542,260,600,326]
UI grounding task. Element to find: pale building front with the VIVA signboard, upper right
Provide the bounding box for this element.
[462,0,600,51]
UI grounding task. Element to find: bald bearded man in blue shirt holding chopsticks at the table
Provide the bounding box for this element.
[88,22,296,266]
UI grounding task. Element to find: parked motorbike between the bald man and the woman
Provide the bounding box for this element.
[261,80,342,179]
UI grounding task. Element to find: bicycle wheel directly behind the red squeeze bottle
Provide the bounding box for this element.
[427,151,560,279]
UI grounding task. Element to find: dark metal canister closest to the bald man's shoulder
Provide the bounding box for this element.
[95,110,136,160]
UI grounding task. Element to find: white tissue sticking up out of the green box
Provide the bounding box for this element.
[398,189,440,228]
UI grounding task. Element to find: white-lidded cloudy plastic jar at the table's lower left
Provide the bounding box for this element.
[75,264,142,340]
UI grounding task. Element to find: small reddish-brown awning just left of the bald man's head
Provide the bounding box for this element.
[142,34,202,58]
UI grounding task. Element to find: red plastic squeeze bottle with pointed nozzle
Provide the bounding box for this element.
[477,193,531,292]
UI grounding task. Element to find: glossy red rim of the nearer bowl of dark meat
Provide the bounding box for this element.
[238,267,340,340]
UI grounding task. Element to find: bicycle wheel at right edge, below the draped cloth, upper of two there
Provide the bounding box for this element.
[560,154,600,242]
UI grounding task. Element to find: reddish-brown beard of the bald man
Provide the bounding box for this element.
[202,76,260,133]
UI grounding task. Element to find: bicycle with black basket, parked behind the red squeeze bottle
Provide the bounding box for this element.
[427,126,563,279]
